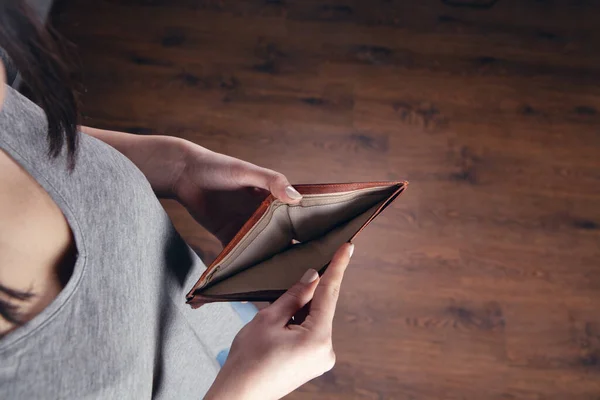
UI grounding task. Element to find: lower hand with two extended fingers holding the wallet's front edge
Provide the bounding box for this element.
[205,243,354,400]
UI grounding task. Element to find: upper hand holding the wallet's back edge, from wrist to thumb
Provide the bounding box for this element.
[173,142,301,245]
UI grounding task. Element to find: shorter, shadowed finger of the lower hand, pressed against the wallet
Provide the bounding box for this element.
[266,269,319,325]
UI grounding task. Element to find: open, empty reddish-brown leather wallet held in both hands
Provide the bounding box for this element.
[187,181,408,308]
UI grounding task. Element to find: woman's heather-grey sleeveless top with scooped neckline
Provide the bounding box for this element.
[0,87,248,400]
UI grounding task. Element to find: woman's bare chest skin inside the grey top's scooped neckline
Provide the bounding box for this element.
[0,150,73,330]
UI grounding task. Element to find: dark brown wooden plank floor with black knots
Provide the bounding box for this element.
[56,0,600,399]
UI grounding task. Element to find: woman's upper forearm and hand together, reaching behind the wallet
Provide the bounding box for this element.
[81,127,300,245]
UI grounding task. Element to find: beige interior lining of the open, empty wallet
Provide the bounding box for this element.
[201,186,397,295]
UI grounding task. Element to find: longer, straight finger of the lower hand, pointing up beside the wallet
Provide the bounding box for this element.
[309,243,354,326]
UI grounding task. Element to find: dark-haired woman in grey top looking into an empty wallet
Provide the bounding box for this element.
[0,0,352,399]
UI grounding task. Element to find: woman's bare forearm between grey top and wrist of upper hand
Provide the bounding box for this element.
[81,126,187,198]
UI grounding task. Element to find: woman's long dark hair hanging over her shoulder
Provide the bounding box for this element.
[0,0,79,171]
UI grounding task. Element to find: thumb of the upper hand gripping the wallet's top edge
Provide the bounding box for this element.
[233,164,302,204]
